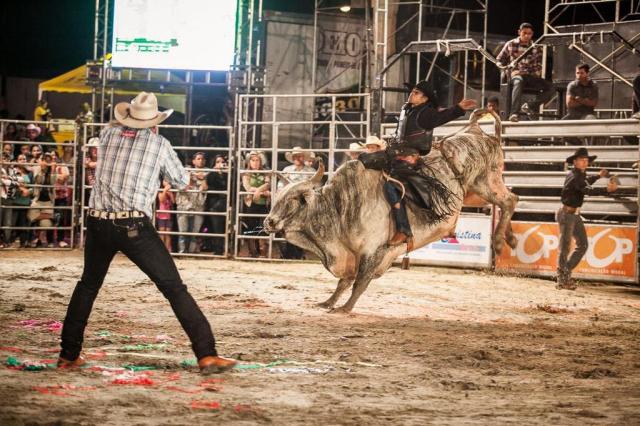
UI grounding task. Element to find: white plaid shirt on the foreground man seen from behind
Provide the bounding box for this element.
[89,125,190,217]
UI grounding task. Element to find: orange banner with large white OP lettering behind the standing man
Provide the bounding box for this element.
[496,222,638,282]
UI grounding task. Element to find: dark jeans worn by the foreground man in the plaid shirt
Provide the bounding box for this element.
[60,217,217,360]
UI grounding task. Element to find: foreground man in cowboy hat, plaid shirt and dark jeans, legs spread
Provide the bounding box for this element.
[58,92,236,374]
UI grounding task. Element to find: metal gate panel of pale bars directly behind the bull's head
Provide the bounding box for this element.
[234,93,370,259]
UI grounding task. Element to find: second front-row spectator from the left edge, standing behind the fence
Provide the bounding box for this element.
[27,153,56,248]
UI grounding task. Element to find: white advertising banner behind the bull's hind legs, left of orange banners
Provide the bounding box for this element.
[409,216,491,268]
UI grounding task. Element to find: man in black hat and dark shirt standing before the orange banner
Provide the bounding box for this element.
[556,148,618,290]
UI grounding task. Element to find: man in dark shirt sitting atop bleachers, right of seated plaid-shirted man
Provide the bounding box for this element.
[562,64,598,120]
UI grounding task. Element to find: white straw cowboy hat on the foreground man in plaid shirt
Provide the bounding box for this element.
[113,92,173,129]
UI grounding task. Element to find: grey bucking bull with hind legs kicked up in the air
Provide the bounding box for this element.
[264,110,518,313]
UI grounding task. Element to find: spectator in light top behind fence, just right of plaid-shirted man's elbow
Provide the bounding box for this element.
[176,152,207,253]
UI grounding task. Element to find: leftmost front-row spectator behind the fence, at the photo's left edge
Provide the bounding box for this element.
[2,154,31,248]
